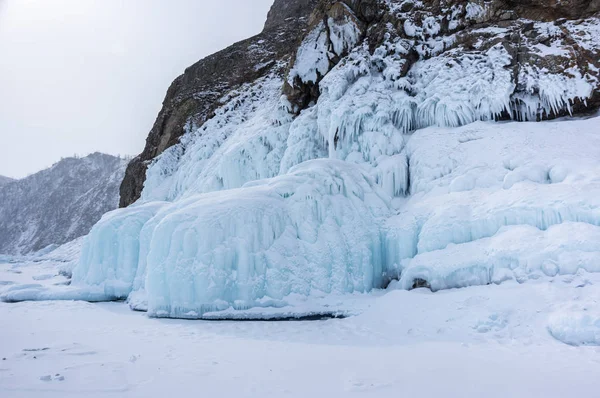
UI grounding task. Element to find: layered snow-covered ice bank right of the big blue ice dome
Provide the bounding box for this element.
[386,117,600,290]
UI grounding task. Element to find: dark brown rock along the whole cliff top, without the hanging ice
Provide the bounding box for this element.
[120,0,600,207]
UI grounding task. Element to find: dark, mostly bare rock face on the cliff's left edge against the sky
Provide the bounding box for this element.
[120,0,317,207]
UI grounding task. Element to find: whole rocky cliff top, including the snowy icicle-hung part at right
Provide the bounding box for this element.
[120,0,600,207]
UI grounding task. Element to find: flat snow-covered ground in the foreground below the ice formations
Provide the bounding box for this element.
[0,261,600,398]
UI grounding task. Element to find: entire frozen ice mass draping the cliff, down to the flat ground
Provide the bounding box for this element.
[2,3,600,318]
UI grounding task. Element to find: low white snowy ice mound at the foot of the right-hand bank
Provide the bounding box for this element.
[399,223,600,291]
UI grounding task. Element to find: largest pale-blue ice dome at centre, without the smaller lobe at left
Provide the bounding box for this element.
[145,160,389,318]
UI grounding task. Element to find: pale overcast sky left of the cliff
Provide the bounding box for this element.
[0,0,273,178]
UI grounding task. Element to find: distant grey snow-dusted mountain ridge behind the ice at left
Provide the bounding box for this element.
[0,153,126,254]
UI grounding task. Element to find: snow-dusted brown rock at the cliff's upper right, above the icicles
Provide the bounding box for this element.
[284,0,600,118]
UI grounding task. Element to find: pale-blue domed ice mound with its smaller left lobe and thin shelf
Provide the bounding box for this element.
[2,159,390,318]
